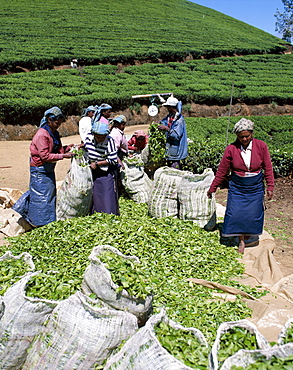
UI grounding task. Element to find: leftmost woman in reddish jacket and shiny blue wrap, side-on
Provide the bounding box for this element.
[13,107,73,226]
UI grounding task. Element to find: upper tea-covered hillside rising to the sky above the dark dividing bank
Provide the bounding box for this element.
[0,0,284,73]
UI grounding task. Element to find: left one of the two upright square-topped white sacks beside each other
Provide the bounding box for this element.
[148,167,190,218]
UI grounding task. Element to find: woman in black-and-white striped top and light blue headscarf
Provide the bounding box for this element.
[85,121,119,215]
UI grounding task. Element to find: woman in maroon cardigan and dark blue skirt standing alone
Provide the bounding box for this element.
[207,118,274,253]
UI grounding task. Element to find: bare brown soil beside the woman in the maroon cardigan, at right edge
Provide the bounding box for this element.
[216,178,293,275]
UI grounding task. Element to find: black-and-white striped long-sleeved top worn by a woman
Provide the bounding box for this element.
[84,134,118,171]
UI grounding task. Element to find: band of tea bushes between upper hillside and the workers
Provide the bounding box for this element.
[0,55,293,124]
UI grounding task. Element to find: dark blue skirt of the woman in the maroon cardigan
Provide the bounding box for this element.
[222,172,264,237]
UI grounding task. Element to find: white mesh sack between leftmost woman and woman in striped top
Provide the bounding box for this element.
[56,156,93,220]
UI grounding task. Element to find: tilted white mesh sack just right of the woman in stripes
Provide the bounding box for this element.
[120,155,152,203]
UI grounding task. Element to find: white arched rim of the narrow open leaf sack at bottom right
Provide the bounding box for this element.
[209,320,270,370]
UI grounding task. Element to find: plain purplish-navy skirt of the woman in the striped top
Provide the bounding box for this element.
[92,168,120,215]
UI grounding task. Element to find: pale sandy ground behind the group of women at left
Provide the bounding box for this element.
[0,125,149,192]
